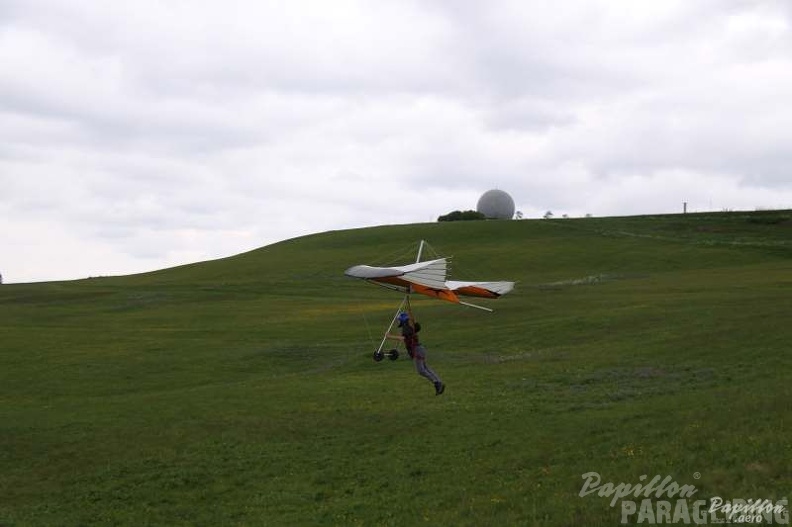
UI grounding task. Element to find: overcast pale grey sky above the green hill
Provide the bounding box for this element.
[0,0,792,283]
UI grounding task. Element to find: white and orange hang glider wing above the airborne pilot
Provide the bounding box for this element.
[344,241,514,311]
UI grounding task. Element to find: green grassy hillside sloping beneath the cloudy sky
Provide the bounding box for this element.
[0,211,792,527]
